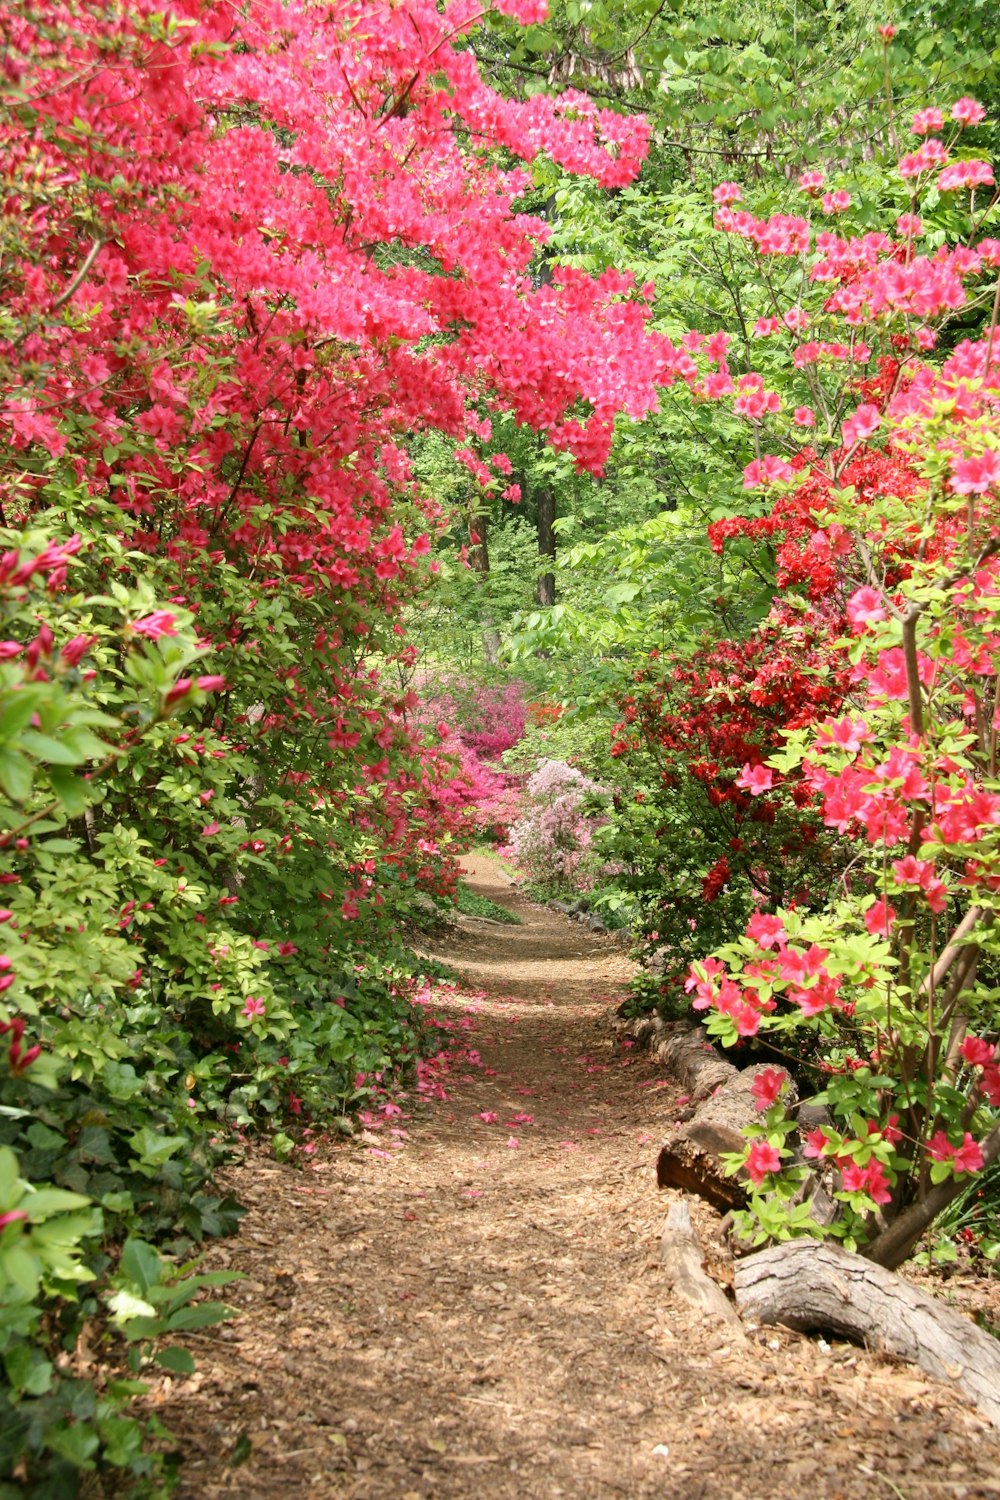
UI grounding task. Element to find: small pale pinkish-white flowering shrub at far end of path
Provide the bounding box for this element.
[510,761,604,891]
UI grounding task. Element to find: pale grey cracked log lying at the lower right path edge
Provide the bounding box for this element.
[735,1239,1000,1428]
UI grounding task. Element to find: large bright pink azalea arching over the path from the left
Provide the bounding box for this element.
[0,0,670,1041]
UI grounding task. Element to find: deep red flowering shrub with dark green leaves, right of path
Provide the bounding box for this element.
[601,602,850,996]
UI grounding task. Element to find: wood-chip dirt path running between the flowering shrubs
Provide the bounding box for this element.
[160,861,1000,1500]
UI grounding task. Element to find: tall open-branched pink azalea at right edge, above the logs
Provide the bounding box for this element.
[685,99,1000,1266]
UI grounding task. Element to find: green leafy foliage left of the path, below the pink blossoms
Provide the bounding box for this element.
[0,513,464,1497]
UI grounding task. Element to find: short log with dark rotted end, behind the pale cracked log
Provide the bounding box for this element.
[657,1064,795,1211]
